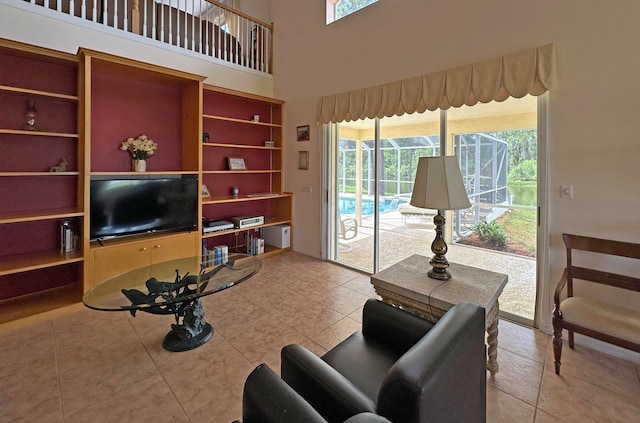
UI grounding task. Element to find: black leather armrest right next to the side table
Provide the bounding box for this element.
[362,299,434,355]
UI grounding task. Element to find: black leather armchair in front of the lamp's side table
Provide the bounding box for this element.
[281,300,486,423]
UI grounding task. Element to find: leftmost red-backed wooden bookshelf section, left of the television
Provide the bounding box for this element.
[0,39,84,325]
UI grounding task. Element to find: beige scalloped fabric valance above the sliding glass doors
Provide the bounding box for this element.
[318,44,555,123]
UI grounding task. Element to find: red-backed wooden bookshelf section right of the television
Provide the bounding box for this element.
[202,85,293,254]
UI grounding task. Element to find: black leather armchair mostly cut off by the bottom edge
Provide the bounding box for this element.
[235,364,390,423]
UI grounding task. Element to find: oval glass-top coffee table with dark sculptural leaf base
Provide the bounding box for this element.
[82,254,262,351]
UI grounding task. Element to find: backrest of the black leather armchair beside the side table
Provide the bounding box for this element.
[377,303,486,423]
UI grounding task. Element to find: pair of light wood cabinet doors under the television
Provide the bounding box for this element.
[87,233,198,288]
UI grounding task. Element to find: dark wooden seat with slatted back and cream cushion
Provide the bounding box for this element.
[552,234,640,375]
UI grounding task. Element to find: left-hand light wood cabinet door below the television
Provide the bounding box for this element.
[86,241,151,289]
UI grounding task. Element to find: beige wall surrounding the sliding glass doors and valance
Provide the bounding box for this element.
[271,0,640,340]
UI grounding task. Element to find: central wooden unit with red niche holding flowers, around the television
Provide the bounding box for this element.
[80,49,203,291]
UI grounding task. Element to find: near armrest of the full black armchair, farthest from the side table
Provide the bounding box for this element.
[281,344,376,421]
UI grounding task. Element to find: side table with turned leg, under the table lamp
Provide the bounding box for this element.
[371,254,508,376]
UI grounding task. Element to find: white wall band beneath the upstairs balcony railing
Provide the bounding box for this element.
[0,0,273,97]
